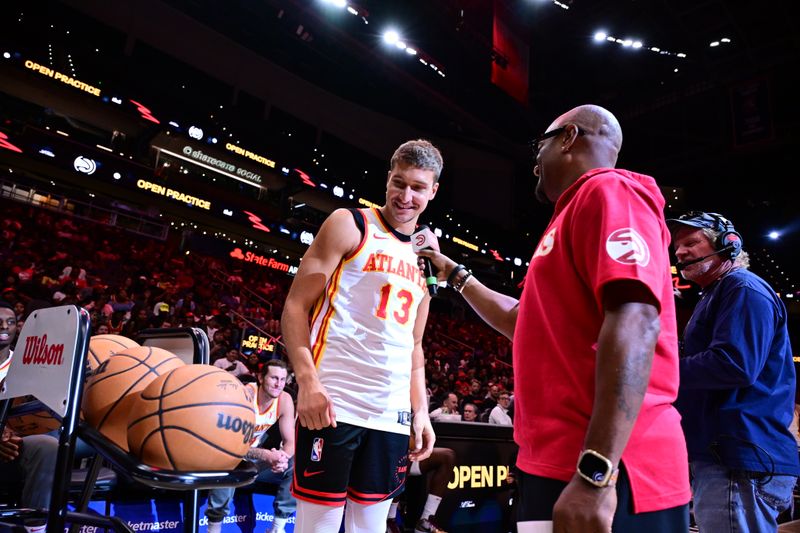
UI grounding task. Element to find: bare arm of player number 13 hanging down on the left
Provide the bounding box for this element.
[281,209,361,429]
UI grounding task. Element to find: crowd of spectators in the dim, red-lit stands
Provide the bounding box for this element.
[0,200,513,422]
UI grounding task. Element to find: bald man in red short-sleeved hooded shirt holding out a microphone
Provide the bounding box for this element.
[420,105,690,533]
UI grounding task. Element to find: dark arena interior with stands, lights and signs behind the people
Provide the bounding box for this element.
[0,0,800,533]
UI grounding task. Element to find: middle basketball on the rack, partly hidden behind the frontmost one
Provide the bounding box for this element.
[83,346,184,451]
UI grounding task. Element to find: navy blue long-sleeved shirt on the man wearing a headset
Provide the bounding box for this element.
[676,269,800,475]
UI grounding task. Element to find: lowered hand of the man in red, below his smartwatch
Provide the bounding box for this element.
[553,474,617,533]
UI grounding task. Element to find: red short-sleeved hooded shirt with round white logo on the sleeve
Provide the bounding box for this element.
[513,169,690,513]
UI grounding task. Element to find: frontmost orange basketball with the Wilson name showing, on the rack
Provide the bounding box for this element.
[128,365,255,470]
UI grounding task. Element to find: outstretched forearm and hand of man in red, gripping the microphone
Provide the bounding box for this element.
[417,249,519,340]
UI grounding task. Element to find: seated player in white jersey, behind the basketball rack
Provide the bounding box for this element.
[206,359,296,533]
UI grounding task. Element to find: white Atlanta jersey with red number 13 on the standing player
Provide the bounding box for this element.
[311,209,426,435]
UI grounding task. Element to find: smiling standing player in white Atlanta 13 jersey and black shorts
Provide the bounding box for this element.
[282,140,442,533]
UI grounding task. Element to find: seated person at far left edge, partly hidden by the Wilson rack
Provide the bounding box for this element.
[0,301,58,533]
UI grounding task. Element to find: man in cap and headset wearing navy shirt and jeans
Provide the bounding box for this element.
[667,212,800,533]
